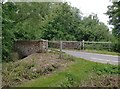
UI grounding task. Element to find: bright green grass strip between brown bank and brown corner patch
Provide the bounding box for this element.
[19,57,120,87]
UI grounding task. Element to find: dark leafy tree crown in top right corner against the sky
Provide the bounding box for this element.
[106,1,120,37]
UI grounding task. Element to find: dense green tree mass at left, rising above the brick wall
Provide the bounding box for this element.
[2,2,50,59]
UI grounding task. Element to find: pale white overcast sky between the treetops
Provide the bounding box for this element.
[66,0,111,27]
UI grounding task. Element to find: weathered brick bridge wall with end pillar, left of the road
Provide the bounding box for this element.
[14,40,48,58]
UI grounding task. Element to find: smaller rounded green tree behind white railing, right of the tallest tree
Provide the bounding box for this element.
[77,14,110,41]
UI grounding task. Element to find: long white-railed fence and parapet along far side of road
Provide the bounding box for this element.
[49,40,111,51]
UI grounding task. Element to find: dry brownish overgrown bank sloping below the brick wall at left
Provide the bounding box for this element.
[2,53,73,87]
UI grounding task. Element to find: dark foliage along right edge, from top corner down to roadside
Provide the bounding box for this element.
[106,0,120,52]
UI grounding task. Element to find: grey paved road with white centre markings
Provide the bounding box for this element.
[63,50,120,65]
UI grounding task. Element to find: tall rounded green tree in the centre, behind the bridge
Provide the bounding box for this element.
[43,3,81,40]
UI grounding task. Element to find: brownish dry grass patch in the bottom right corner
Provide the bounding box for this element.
[79,73,120,87]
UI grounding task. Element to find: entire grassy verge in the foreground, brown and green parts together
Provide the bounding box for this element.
[3,51,120,87]
